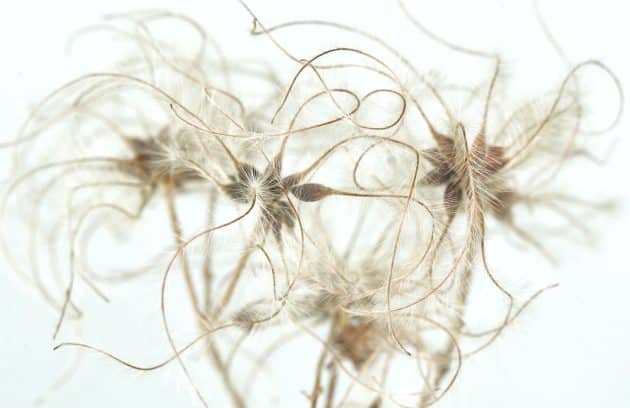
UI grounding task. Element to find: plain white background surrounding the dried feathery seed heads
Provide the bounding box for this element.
[0,0,630,407]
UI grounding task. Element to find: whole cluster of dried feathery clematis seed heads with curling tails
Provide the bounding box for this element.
[0,1,624,408]
